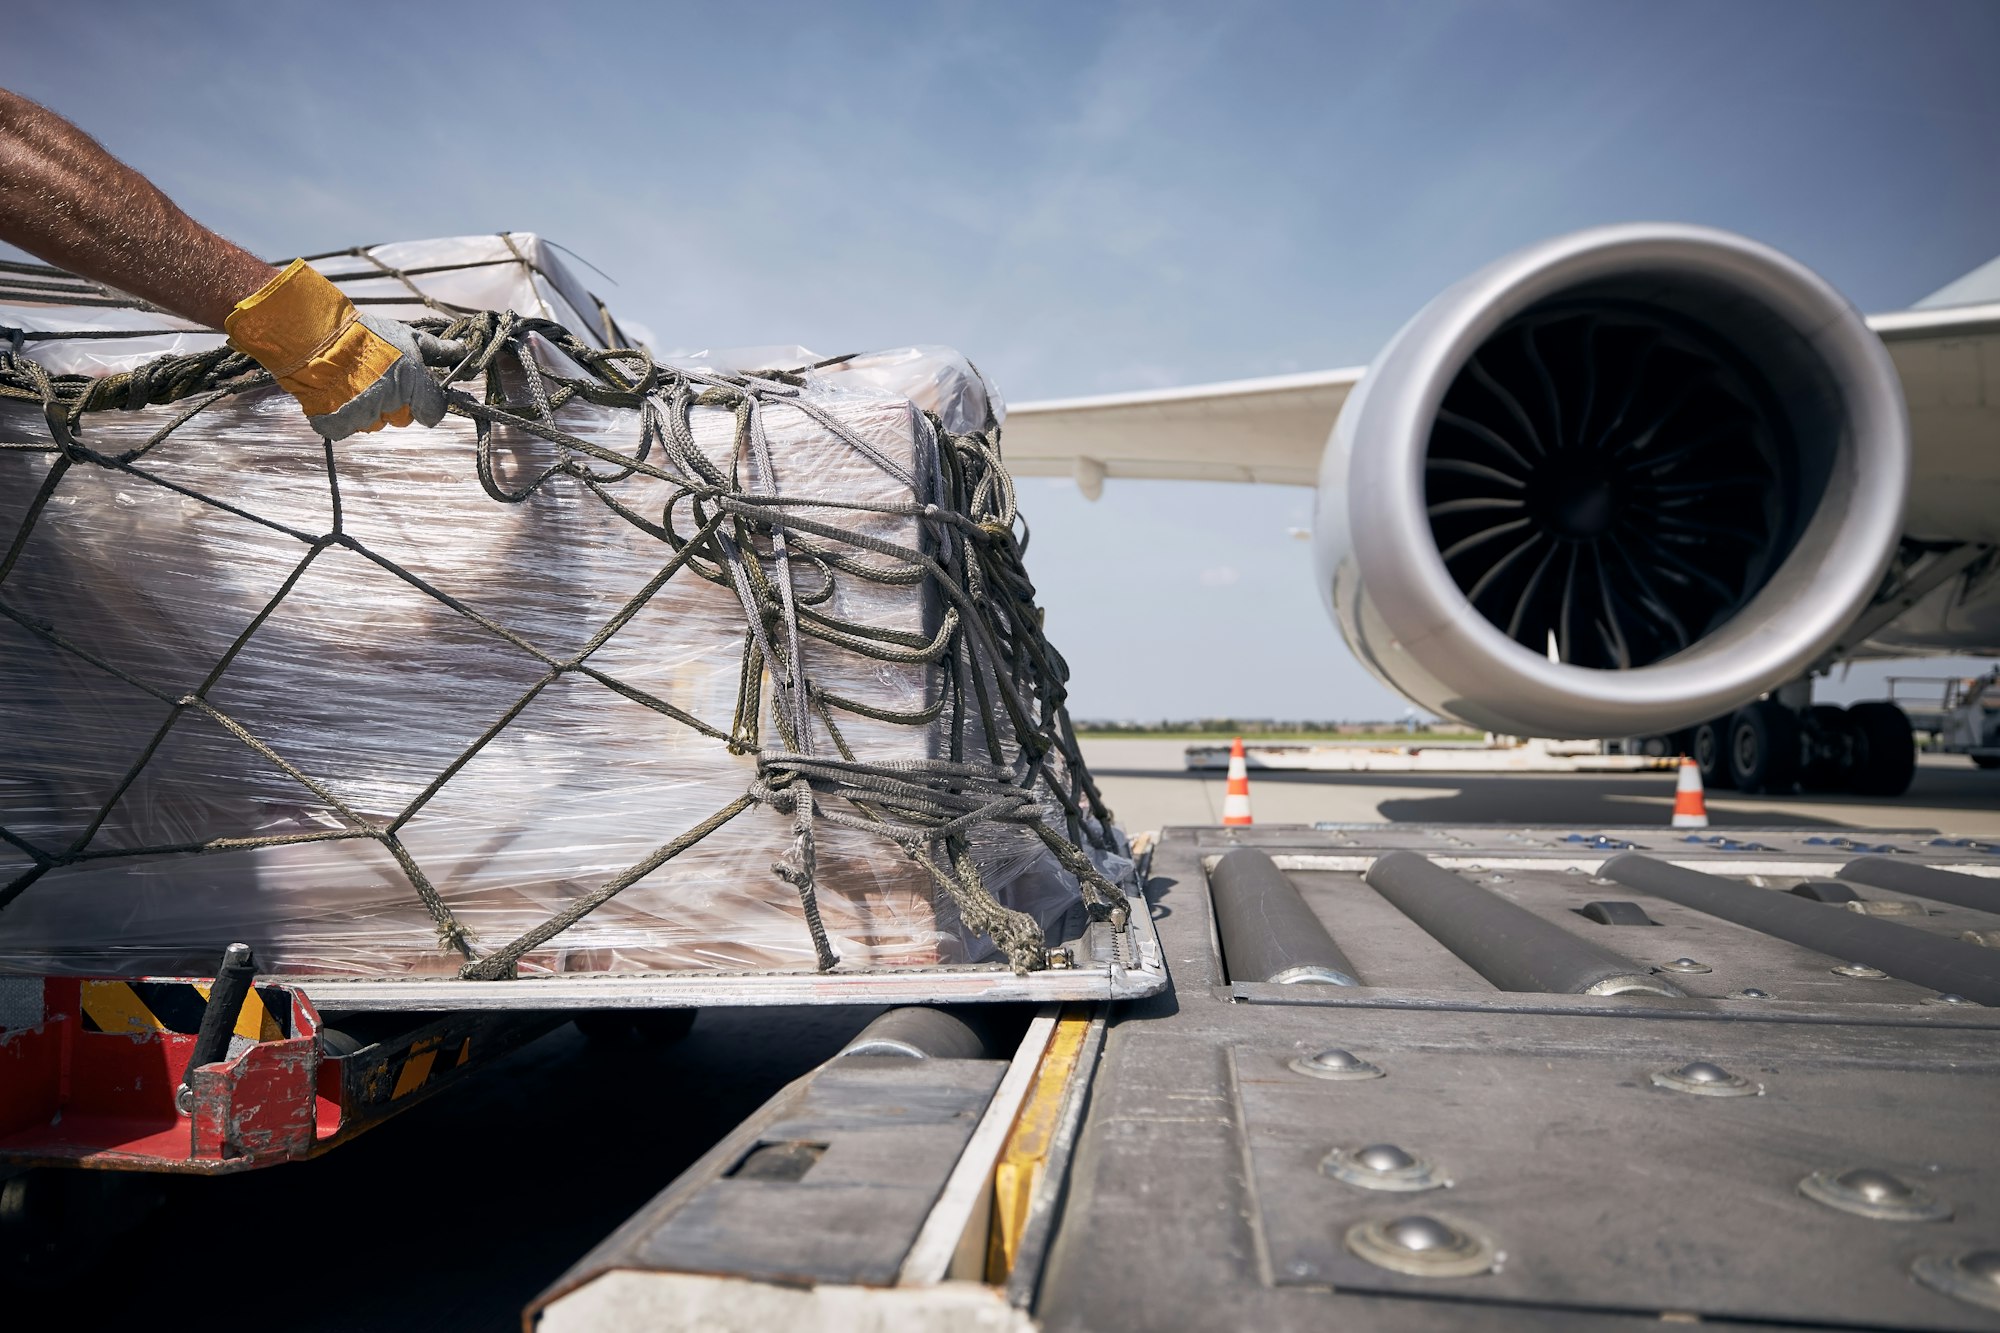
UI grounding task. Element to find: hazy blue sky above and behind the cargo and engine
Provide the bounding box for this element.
[0,0,2000,717]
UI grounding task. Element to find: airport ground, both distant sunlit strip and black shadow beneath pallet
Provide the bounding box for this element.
[12,741,2000,1333]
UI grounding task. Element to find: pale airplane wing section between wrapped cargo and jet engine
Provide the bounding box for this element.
[1004,366,1362,500]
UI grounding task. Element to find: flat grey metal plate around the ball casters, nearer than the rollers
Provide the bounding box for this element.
[1232,1015,2000,1329]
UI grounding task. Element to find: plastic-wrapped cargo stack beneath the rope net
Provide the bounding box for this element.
[0,234,1130,977]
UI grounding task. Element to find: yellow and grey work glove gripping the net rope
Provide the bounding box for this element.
[222,260,444,440]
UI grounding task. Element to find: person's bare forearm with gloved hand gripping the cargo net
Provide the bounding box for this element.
[0,88,444,440]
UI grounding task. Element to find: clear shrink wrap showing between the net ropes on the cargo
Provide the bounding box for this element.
[0,236,1130,977]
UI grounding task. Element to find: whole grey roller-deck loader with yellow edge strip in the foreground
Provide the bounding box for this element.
[528,825,2000,1333]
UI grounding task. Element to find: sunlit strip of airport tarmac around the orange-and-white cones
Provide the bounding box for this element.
[1082,739,2000,837]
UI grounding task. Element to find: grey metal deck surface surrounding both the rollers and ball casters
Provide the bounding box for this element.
[1036,827,2000,1333]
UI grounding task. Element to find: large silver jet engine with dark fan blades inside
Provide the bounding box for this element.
[1314,224,1910,737]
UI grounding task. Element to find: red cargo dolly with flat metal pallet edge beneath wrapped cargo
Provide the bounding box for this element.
[0,896,1166,1173]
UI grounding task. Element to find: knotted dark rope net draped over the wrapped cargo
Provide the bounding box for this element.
[0,302,1128,981]
